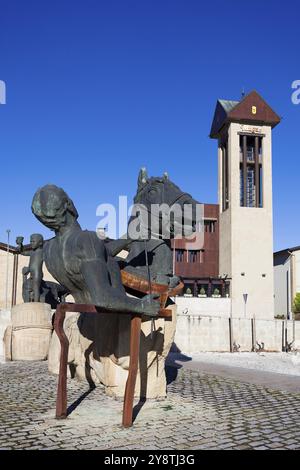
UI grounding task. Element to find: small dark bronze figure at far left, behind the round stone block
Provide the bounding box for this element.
[16,233,44,302]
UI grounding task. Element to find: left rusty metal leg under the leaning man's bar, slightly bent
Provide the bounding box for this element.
[54,305,69,419]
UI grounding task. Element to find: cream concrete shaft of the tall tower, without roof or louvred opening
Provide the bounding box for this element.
[219,123,274,319]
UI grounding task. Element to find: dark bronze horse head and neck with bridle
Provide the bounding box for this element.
[124,168,201,287]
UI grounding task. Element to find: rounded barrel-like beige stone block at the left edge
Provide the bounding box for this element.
[4,302,53,361]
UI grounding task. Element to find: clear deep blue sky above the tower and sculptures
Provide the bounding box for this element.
[0,0,300,249]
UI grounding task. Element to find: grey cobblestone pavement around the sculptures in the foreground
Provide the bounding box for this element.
[0,362,300,450]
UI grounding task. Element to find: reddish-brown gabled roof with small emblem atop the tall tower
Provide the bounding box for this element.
[210,90,281,139]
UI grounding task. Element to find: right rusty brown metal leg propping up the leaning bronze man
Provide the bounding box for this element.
[122,315,142,428]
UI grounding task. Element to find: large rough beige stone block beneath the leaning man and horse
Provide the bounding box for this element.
[48,305,176,398]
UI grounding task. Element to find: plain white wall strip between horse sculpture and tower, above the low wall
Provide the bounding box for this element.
[174,297,231,318]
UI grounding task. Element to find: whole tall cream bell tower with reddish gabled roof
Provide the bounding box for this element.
[210,91,280,319]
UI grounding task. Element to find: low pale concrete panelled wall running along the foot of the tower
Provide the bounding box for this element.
[175,312,300,353]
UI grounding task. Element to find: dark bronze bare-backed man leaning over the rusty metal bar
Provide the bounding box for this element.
[32,185,159,316]
